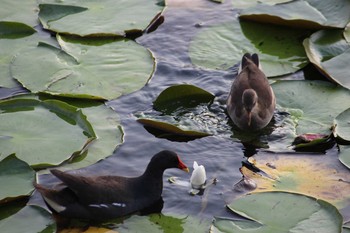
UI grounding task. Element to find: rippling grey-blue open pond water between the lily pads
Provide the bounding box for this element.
[1,0,350,228]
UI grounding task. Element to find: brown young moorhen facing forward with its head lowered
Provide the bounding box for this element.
[226,53,276,131]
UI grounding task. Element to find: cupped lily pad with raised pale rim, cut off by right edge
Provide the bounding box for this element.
[303,30,350,89]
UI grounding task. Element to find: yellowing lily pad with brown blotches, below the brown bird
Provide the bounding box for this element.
[241,154,350,207]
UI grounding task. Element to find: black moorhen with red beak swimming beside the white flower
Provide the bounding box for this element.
[35,150,189,221]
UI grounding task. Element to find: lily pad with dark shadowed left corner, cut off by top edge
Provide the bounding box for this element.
[39,0,163,36]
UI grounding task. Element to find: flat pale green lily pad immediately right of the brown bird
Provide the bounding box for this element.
[271,81,350,135]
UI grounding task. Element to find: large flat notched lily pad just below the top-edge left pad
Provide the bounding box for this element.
[11,36,154,99]
